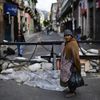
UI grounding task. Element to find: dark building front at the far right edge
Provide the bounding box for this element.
[88,0,100,40]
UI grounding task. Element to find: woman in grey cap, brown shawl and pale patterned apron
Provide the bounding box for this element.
[60,29,81,97]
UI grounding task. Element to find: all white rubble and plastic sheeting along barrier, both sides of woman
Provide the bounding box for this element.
[0,48,100,91]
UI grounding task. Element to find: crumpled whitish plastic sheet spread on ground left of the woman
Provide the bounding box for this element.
[0,70,64,91]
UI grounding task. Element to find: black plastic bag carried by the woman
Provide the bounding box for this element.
[68,71,84,88]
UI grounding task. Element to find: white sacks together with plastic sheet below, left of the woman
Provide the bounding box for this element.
[0,57,64,91]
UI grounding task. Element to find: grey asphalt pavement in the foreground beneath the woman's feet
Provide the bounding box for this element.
[0,75,100,100]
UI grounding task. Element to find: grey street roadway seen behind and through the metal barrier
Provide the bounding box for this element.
[24,32,63,57]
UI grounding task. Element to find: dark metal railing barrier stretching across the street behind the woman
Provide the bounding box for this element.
[0,41,100,69]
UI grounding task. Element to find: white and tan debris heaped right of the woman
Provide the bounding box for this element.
[79,48,100,73]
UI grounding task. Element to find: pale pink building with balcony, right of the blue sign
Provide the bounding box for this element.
[18,0,37,34]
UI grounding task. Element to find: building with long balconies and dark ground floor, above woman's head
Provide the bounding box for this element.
[57,0,79,31]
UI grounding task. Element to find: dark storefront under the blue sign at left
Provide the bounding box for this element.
[4,3,18,41]
